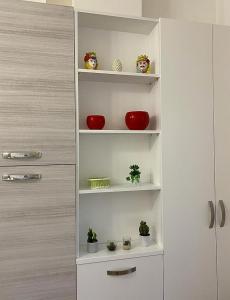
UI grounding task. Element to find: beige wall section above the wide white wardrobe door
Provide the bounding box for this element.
[143,0,217,23]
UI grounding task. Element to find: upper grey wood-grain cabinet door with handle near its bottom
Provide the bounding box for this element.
[0,0,75,166]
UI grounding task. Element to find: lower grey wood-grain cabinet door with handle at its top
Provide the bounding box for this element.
[0,166,76,300]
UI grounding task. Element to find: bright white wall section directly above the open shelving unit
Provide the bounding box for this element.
[74,0,142,16]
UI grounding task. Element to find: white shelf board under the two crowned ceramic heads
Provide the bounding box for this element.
[78,69,160,84]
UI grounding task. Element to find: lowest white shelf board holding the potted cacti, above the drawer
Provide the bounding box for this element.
[76,244,163,265]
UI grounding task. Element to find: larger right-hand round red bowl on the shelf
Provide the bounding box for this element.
[125,111,149,130]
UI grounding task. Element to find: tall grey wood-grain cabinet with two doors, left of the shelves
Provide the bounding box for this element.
[0,0,76,300]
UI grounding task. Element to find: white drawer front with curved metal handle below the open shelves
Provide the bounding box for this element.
[77,255,163,300]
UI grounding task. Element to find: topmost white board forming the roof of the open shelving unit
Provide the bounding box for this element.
[78,10,159,35]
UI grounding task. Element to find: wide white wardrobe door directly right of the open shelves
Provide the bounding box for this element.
[161,20,217,300]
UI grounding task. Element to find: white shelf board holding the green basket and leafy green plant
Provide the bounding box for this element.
[79,183,161,195]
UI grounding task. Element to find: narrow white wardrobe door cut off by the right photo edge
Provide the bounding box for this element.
[213,26,230,300]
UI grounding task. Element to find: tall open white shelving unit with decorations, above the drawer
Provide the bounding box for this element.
[76,11,163,265]
